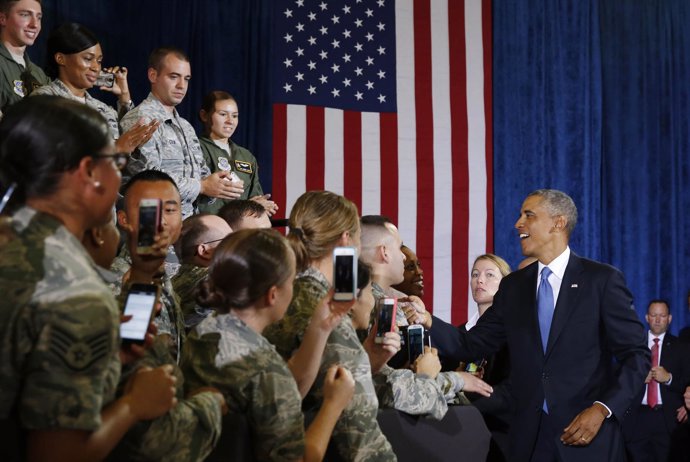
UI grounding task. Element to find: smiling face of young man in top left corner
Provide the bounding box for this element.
[0,0,43,48]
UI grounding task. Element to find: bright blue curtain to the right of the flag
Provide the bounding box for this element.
[493,0,690,332]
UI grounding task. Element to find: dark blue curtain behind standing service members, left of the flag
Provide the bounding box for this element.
[29,0,273,192]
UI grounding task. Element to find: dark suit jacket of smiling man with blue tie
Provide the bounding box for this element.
[431,252,650,462]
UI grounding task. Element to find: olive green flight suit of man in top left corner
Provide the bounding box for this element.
[0,43,50,112]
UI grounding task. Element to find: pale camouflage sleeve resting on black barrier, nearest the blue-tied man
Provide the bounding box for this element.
[374,366,448,420]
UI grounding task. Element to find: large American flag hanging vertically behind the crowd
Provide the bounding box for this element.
[273,0,493,324]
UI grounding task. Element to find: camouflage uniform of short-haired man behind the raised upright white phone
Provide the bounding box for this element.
[110,246,185,358]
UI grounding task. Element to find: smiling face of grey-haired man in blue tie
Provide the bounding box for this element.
[515,195,568,265]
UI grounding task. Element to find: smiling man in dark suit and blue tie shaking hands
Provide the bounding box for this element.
[412,190,650,462]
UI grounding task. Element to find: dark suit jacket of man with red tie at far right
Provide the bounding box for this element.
[623,332,690,439]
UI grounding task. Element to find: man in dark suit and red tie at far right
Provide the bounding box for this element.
[623,300,690,462]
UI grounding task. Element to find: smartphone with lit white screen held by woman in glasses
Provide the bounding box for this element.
[120,284,158,344]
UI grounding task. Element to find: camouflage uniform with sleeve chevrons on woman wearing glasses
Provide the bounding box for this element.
[0,207,120,449]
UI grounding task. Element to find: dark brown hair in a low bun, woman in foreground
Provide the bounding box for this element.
[197,229,294,313]
